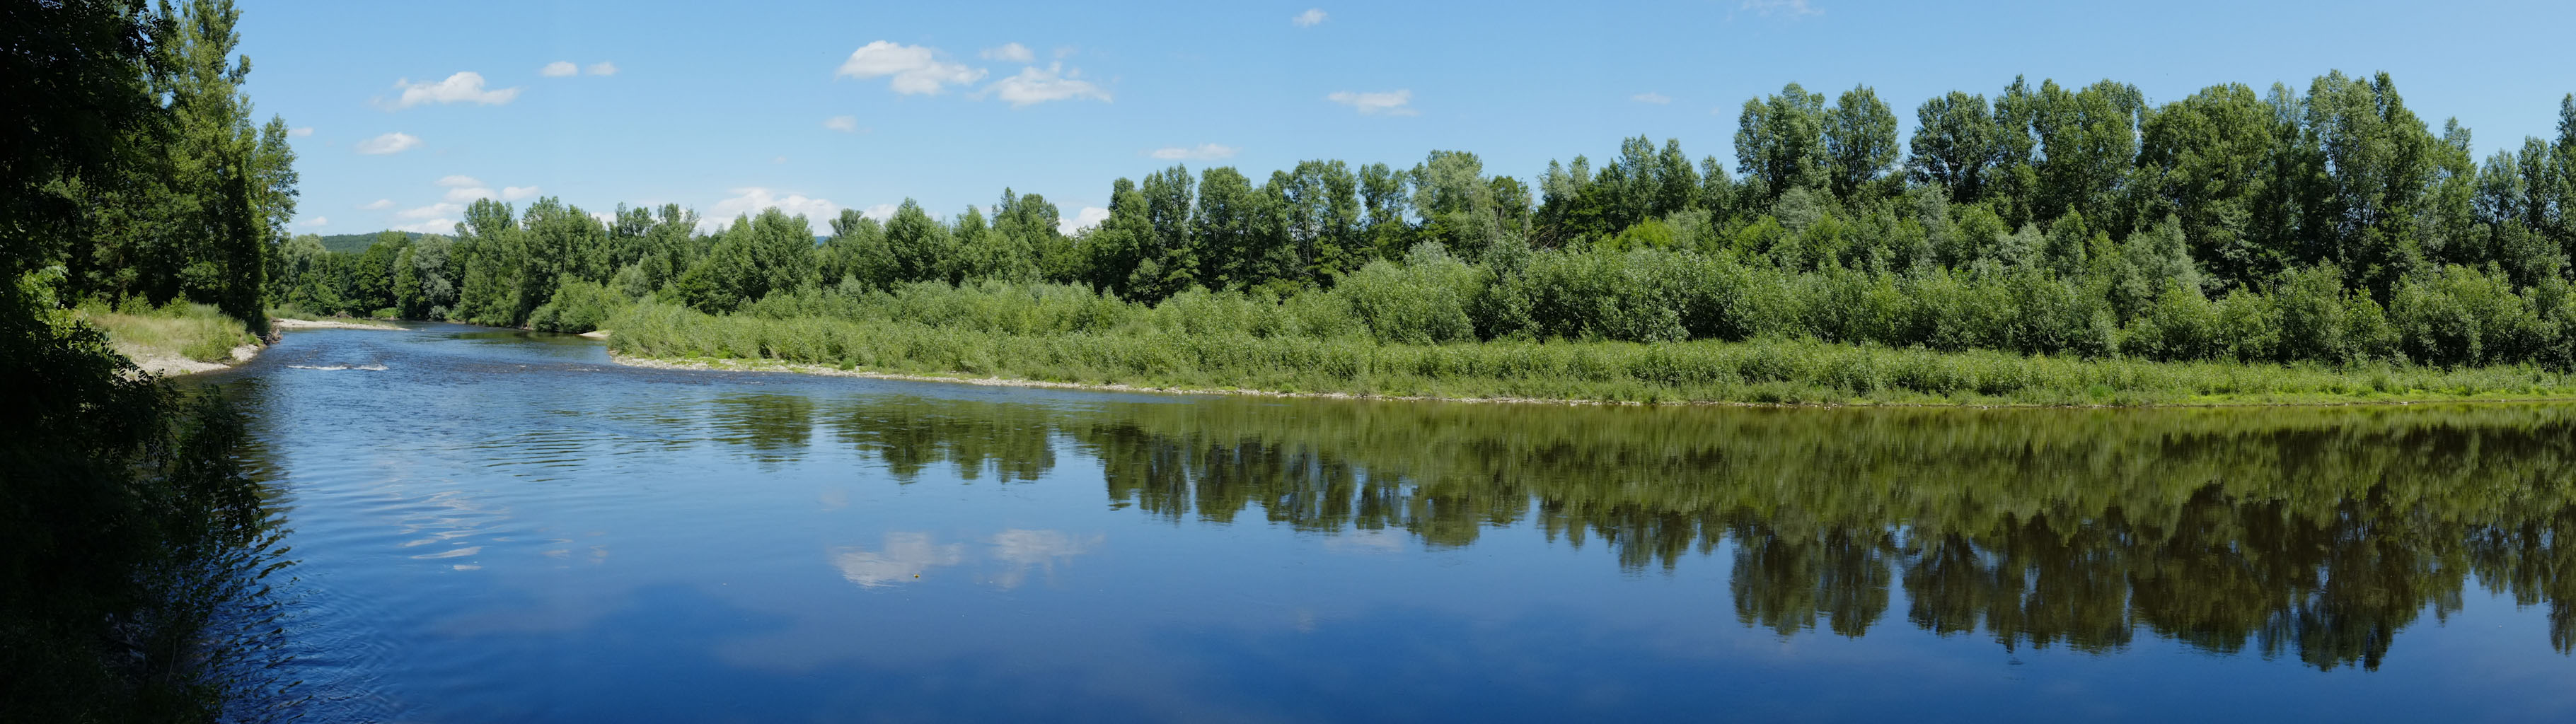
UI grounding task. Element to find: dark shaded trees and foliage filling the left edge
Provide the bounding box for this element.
[0,0,296,721]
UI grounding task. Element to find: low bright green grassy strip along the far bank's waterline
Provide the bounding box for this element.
[592,304,2576,407]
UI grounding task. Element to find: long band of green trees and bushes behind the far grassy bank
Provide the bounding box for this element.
[292,72,2576,368]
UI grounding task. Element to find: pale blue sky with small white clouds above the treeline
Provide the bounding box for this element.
[240,0,2576,235]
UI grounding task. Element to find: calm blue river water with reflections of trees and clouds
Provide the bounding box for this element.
[214,327,2576,721]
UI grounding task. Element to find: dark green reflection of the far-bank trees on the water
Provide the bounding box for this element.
[714,395,2576,670]
